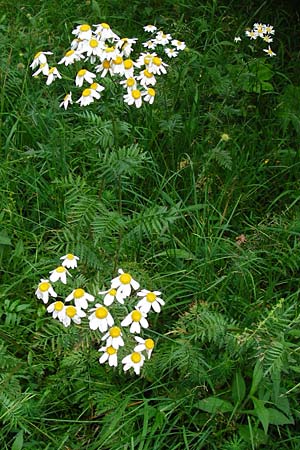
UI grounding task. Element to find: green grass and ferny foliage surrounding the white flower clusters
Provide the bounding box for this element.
[0,0,300,450]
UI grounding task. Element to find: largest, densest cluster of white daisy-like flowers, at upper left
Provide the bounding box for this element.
[30,23,185,109]
